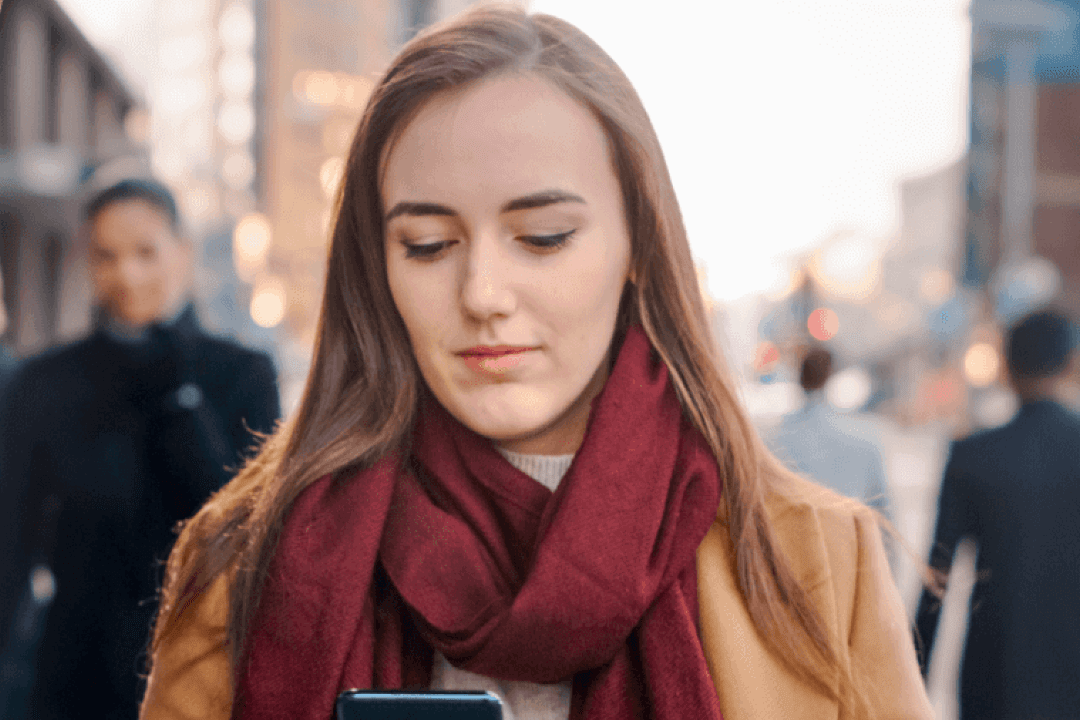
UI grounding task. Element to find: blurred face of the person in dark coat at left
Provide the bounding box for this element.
[90,199,191,326]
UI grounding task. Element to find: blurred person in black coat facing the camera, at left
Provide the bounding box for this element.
[0,175,280,720]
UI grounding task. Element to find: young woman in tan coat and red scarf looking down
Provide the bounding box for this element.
[143,8,931,720]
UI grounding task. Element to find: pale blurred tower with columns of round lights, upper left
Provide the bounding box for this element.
[149,0,262,344]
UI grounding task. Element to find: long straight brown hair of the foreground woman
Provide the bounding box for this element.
[153,6,850,703]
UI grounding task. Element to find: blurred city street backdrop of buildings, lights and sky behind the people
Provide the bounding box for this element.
[0,0,1080,719]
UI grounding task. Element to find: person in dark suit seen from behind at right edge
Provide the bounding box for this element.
[916,311,1080,720]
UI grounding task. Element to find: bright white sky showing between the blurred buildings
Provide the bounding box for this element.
[60,0,970,300]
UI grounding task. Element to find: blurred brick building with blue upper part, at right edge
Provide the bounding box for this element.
[963,0,1080,320]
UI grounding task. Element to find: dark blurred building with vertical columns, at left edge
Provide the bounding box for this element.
[0,0,144,353]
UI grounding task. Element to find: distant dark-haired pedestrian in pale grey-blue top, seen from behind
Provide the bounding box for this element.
[768,347,889,512]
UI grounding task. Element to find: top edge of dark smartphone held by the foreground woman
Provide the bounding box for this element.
[337,690,502,720]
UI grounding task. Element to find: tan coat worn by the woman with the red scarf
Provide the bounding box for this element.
[140,480,933,720]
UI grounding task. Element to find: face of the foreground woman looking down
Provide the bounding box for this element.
[381,76,631,454]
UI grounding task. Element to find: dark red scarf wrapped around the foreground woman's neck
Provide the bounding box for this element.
[233,327,721,720]
